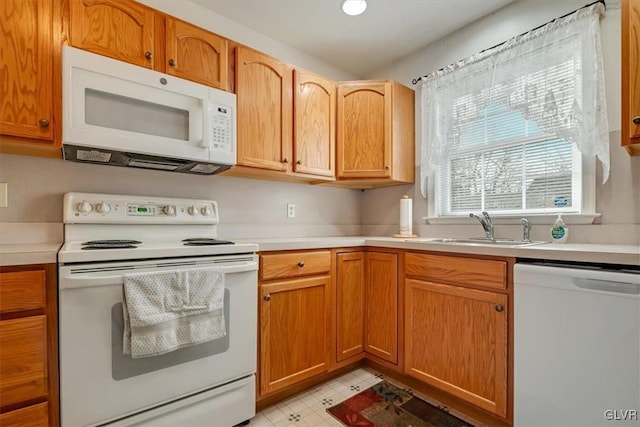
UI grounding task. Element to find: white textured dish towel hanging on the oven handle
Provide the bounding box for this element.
[122,267,226,358]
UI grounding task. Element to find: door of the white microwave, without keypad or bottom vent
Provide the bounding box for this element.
[63,50,210,161]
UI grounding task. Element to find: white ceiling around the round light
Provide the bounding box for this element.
[193,0,514,78]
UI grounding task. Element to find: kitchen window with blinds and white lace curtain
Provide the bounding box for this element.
[421,3,609,221]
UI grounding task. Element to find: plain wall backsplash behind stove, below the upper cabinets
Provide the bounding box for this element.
[0,154,362,237]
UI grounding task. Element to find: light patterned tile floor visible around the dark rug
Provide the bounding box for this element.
[249,368,481,427]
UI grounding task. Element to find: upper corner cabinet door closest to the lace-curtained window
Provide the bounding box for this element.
[337,81,392,178]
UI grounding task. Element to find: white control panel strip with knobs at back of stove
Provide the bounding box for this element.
[63,193,218,224]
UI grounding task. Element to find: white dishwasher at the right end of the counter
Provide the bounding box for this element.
[514,263,640,427]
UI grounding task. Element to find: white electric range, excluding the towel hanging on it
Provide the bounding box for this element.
[58,193,258,427]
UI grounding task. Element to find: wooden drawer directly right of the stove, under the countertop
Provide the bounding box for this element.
[260,251,331,280]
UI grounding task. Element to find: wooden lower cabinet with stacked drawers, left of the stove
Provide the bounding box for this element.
[0,264,59,427]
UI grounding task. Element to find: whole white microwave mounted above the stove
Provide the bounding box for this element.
[62,46,236,174]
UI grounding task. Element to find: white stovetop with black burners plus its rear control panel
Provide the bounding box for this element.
[58,193,258,263]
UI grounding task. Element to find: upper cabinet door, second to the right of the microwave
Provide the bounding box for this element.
[293,70,336,177]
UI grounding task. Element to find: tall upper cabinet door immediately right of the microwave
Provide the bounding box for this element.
[236,47,293,171]
